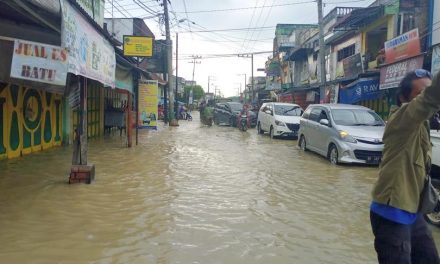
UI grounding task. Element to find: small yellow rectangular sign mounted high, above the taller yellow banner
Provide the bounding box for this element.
[124,36,153,57]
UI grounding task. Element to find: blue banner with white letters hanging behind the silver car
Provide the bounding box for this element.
[338,78,382,104]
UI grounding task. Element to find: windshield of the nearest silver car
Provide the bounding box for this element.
[332,109,385,126]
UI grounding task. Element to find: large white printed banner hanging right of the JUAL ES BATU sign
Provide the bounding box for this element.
[61,0,116,88]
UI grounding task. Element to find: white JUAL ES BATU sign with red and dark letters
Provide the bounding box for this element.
[11,40,68,86]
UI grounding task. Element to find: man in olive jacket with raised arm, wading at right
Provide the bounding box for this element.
[370,69,440,264]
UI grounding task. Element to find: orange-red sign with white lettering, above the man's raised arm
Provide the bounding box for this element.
[385,28,421,64]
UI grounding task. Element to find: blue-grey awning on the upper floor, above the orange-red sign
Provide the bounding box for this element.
[334,6,385,31]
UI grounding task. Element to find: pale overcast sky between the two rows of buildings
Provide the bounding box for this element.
[106,0,374,96]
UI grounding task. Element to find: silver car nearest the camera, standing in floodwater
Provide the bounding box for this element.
[298,104,385,164]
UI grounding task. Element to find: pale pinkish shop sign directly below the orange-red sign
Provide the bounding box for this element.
[380,55,423,90]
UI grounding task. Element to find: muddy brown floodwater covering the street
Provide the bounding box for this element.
[0,116,440,264]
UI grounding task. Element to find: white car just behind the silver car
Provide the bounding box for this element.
[257,103,304,138]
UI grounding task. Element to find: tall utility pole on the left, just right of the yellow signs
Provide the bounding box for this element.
[163,0,175,124]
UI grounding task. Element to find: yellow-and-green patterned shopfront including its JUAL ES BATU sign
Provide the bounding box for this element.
[0,37,67,159]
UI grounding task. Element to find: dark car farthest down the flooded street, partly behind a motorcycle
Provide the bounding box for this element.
[214,102,257,127]
